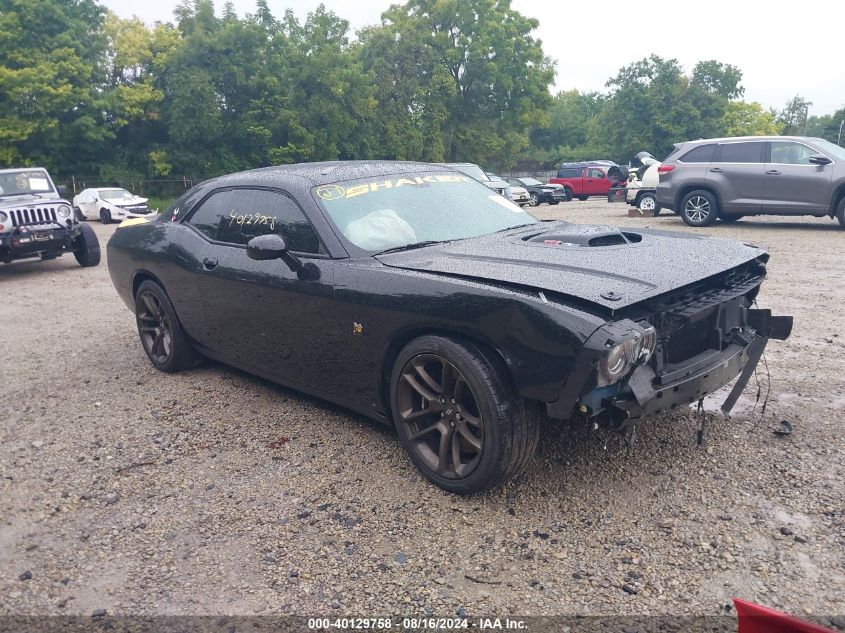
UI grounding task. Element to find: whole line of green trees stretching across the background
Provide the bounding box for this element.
[0,0,845,188]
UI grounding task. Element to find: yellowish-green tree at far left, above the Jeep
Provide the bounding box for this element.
[0,0,110,173]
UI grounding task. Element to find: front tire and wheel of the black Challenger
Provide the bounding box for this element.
[390,336,540,494]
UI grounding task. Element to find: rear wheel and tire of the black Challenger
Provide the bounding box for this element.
[135,279,200,373]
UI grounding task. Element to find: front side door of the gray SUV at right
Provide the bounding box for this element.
[763,140,833,214]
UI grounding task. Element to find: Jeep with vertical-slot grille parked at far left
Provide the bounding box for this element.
[0,167,100,266]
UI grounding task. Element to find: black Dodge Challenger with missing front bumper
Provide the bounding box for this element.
[108,162,792,493]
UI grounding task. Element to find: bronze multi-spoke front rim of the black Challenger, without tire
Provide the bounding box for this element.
[396,353,484,479]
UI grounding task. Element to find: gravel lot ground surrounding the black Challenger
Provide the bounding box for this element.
[0,201,845,623]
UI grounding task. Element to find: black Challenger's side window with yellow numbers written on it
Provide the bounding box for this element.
[188,189,325,253]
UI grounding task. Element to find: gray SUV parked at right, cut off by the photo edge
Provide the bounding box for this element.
[657,136,845,228]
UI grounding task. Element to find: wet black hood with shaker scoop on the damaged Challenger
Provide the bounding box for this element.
[378,222,768,312]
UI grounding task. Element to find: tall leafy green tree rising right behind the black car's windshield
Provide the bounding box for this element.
[361,0,554,166]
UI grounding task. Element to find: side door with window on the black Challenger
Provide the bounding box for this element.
[175,188,341,392]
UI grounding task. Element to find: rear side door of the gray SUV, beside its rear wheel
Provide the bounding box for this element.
[707,141,766,213]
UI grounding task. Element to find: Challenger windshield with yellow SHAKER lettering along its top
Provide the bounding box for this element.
[314,172,537,253]
